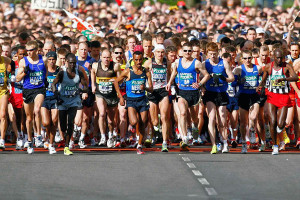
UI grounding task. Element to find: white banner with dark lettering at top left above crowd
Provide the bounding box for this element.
[31,0,64,10]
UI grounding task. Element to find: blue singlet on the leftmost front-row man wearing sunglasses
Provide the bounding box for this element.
[23,55,46,89]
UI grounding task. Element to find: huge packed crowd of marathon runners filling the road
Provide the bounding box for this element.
[0,0,300,155]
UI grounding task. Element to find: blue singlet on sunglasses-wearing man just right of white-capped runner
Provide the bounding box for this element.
[177,58,198,90]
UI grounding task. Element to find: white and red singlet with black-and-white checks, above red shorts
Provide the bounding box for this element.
[268,62,290,94]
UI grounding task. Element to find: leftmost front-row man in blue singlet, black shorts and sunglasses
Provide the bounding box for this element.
[16,41,47,154]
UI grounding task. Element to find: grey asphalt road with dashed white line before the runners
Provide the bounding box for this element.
[0,148,300,200]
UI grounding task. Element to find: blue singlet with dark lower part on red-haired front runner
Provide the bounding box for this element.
[205,58,228,92]
